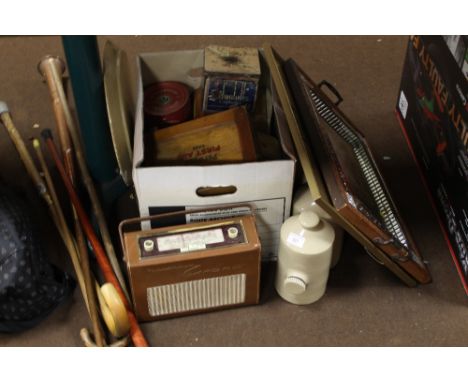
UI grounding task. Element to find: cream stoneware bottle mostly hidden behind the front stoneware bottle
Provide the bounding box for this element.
[292,184,344,268]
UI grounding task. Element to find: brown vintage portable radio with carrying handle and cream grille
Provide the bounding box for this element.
[119,209,261,321]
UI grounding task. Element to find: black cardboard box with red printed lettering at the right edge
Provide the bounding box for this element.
[397,36,468,293]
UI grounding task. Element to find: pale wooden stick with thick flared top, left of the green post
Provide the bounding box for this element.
[38,56,129,300]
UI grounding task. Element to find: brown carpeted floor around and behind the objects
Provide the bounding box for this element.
[0,36,462,346]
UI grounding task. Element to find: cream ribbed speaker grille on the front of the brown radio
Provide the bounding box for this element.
[147,273,246,317]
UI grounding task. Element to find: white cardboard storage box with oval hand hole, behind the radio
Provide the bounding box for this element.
[132,50,295,260]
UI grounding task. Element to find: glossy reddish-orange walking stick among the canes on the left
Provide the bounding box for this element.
[41,129,148,346]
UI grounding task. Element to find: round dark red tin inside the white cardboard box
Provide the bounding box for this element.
[143,81,192,127]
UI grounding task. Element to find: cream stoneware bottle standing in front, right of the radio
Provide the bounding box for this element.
[275,209,335,305]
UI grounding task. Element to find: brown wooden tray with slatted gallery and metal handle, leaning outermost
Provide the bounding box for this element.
[284,60,431,283]
